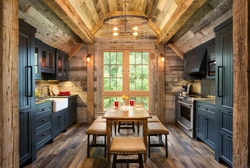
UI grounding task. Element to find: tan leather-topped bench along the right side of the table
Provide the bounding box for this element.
[148,122,169,158]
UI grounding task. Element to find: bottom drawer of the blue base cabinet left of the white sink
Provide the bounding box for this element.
[36,125,52,149]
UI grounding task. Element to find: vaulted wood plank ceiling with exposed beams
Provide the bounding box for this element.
[19,0,232,53]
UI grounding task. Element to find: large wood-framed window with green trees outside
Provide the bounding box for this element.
[103,51,150,110]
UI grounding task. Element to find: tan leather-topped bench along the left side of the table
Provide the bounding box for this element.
[86,122,106,158]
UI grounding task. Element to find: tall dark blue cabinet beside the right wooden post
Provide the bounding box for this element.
[215,18,233,166]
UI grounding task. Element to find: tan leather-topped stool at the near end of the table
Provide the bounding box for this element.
[110,137,146,168]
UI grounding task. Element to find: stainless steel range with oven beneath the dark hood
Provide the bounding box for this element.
[177,95,208,138]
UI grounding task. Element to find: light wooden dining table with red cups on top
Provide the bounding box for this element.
[103,106,152,162]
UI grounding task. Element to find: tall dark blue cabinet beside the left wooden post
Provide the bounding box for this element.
[18,20,36,165]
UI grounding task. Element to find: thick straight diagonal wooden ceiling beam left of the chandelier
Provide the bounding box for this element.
[43,0,94,44]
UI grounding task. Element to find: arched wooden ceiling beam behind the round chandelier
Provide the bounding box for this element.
[91,11,161,35]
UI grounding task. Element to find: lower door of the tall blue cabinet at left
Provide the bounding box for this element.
[19,112,31,165]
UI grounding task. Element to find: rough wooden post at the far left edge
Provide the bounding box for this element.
[0,0,19,167]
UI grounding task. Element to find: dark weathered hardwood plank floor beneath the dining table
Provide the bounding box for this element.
[23,124,227,168]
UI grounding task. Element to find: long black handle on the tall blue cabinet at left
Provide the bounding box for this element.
[25,66,33,97]
